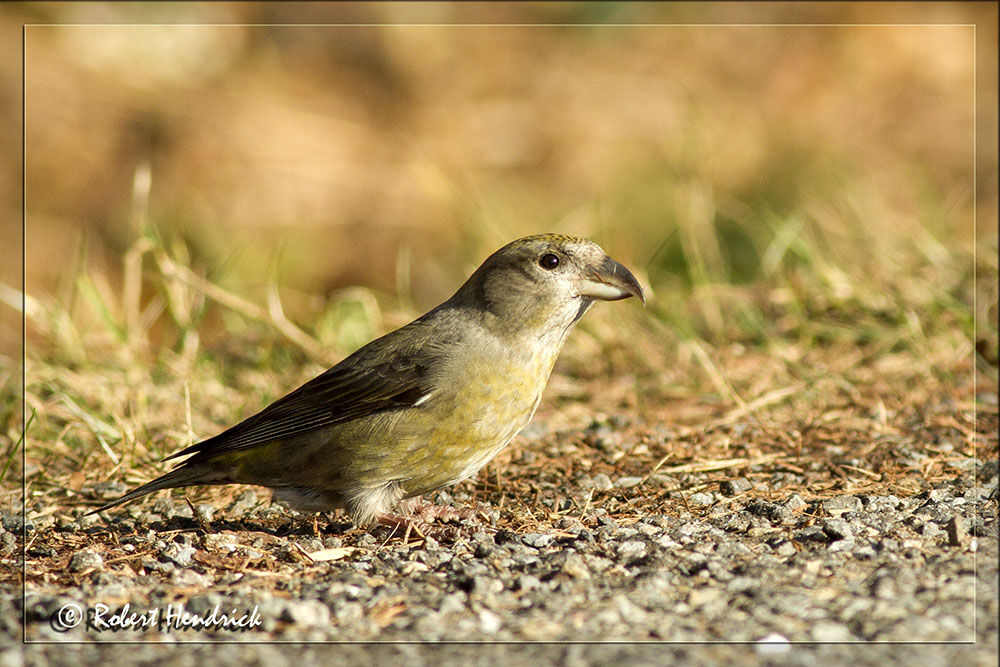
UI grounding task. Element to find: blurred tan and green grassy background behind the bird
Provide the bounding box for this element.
[0,2,997,494]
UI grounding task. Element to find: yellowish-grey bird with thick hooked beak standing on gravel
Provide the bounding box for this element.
[90,234,645,525]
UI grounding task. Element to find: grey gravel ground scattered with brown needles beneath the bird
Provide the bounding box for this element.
[0,461,998,665]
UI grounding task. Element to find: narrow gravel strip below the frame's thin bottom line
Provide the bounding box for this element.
[0,644,996,667]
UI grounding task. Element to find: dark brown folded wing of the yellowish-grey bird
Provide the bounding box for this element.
[167,331,438,464]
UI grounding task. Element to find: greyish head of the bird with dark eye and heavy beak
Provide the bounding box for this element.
[453,234,646,340]
